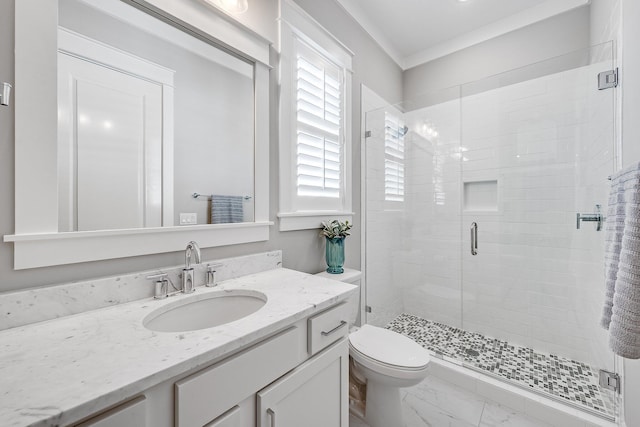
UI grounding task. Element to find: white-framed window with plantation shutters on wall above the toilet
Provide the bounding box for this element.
[278,0,353,231]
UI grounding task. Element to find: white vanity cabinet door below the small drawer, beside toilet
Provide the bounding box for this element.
[257,339,349,427]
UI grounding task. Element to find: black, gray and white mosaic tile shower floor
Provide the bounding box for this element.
[387,314,615,417]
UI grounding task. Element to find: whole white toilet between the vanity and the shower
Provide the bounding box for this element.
[318,268,429,427]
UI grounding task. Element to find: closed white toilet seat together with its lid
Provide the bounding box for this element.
[349,325,429,378]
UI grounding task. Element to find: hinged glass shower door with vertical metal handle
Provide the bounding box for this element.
[459,43,616,419]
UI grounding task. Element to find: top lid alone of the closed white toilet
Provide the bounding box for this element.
[349,325,429,368]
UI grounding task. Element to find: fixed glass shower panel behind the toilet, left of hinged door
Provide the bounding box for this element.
[363,88,461,329]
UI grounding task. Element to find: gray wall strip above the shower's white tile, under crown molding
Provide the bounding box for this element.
[403,7,589,101]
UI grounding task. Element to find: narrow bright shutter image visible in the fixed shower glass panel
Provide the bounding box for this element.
[384,113,406,202]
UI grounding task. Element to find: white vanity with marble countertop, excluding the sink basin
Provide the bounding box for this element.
[0,266,355,427]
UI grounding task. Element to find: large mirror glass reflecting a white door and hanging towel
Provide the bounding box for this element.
[58,0,255,232]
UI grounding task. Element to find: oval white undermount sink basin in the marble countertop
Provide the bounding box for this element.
[142,290,267,332]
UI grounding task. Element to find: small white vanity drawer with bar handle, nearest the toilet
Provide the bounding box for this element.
[307,302,349,355]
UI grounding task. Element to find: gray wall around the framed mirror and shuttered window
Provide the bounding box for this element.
[0,0,402,291]
